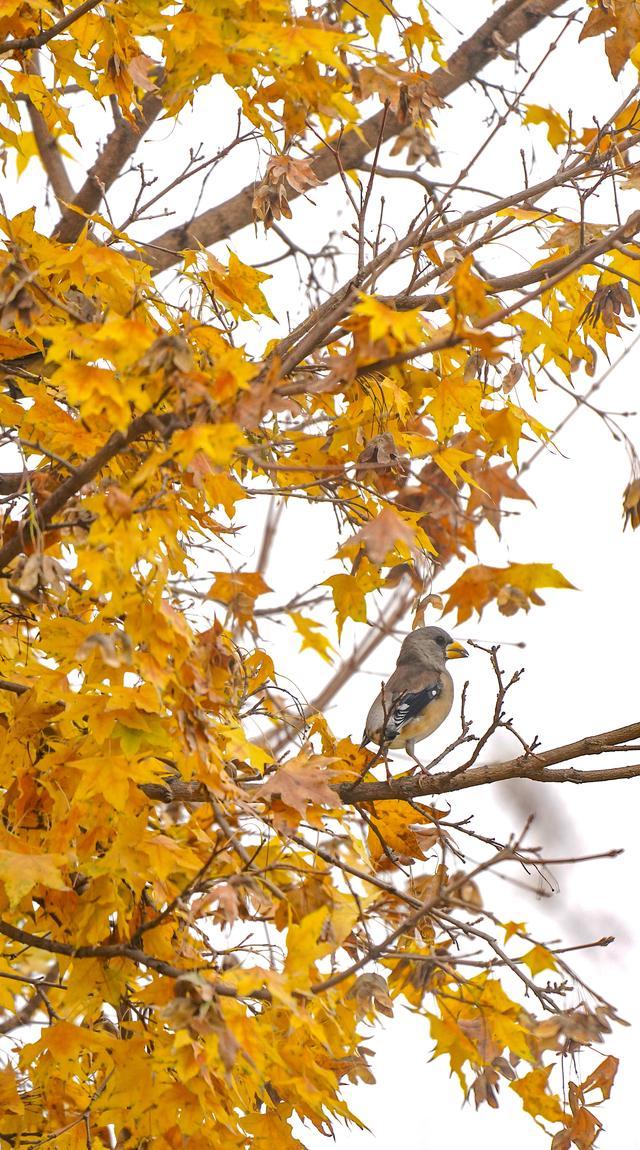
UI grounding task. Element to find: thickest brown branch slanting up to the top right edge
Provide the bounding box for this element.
[140,0,564,271]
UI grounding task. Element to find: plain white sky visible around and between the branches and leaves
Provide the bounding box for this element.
[2,0,640,1150]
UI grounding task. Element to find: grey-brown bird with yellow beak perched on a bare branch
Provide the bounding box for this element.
[361,627,469,771]
